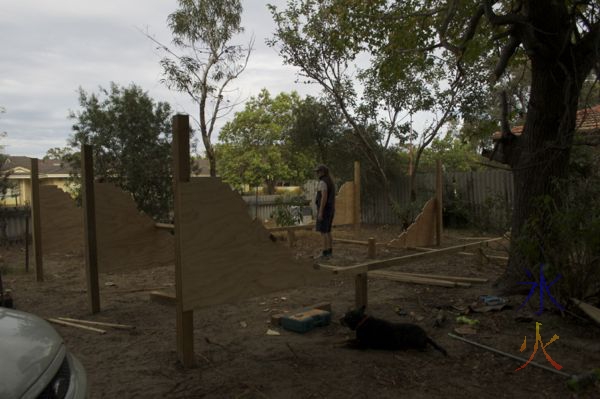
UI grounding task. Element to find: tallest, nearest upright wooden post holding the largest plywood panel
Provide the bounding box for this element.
[172,114,195,367]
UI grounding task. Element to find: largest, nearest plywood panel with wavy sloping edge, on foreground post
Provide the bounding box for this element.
[179,178,327,310]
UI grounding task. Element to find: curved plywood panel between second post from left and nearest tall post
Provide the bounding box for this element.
[94,183,175,273]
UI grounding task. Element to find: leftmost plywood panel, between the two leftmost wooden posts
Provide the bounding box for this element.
[40,186,83,254]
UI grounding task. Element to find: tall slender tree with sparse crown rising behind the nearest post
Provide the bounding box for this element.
[151,0,253,176]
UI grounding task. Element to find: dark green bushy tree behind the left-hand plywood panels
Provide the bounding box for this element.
[68,83,173,220]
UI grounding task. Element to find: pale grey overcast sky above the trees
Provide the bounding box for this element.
[0,0,318,157]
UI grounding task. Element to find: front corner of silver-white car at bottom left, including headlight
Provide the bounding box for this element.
[0,307,87,399]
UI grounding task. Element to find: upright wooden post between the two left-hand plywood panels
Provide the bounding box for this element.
[81,145,100,314]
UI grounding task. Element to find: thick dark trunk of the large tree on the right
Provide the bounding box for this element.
[498,54,579,291]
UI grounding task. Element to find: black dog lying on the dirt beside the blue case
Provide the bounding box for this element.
[340,306,448,356]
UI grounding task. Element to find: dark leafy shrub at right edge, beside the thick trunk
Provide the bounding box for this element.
[517,153,600,303]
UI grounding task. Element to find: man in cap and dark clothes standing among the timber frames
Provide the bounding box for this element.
[315,165,335,257]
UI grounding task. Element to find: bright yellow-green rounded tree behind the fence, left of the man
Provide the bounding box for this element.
[217,89,314,193]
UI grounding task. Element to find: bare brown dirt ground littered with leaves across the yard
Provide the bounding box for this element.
[0,226,600,398]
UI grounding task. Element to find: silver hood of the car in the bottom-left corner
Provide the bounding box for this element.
[0,307,64,398]
